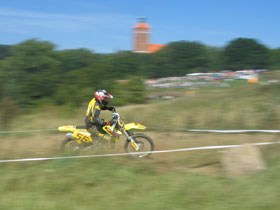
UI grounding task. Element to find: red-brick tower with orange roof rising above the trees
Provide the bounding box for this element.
[133,18,151,53]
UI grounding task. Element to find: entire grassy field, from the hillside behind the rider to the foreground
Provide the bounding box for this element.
[0,71,280,210]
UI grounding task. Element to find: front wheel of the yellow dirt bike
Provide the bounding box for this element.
[124,134,155,158]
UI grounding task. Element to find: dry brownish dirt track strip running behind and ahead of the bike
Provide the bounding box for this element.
[0,132,280,173]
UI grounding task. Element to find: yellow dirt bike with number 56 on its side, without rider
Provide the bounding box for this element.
[58,112,154,158]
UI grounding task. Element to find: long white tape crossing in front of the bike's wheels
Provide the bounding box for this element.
[0,141,280,163]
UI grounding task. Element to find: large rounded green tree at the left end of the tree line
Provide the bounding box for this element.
[2,39,59,105]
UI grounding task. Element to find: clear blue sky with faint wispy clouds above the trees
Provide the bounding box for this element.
[0,0,280,53]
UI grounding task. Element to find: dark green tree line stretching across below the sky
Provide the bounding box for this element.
[0,38,280,112]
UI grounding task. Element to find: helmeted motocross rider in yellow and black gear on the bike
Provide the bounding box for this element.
[85,89,115,136]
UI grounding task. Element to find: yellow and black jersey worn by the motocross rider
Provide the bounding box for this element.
[86,98,107,126]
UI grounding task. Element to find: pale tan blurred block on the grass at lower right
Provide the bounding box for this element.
[222,144,266,177]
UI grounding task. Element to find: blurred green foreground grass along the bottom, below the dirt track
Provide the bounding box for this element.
[0,150,280,210]
